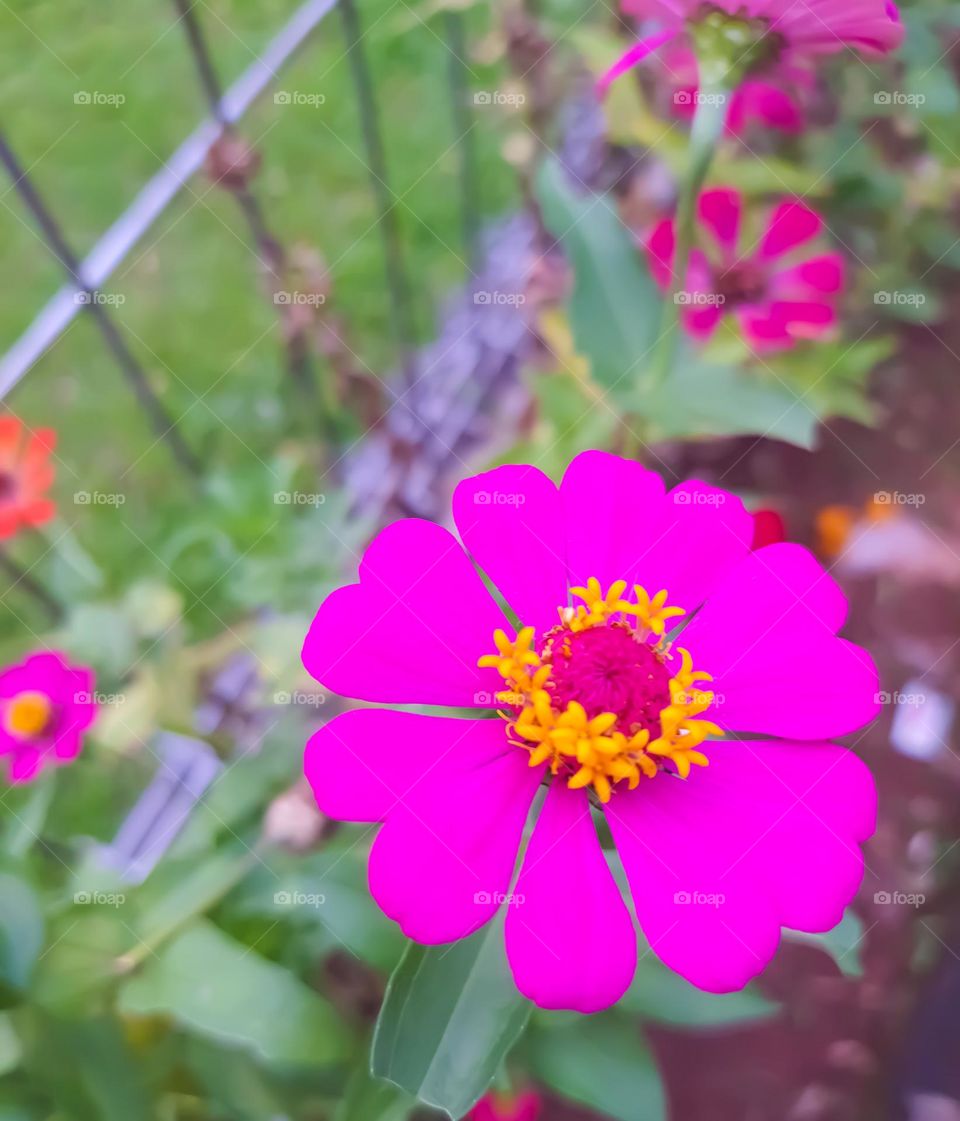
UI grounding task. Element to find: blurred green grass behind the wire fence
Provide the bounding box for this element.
[0,0,514,497]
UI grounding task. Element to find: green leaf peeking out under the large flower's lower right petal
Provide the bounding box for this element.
[617,952,778,1029]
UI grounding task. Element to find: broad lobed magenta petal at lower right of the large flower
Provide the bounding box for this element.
[607,742,876,992]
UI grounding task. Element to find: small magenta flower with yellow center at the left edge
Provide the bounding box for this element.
[0,652,96,782]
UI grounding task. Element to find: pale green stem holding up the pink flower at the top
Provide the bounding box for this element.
[650,86,728,389]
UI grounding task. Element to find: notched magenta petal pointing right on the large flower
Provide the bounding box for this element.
[680,545,879,740]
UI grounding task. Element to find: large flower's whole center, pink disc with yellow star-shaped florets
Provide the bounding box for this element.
[479,577,723,803]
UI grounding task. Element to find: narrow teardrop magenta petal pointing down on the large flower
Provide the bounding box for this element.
[506,782,637,1012]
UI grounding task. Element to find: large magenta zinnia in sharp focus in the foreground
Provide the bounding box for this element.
[303,452,878,1012]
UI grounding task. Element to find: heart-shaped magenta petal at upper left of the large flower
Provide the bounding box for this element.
[303,519,507,707]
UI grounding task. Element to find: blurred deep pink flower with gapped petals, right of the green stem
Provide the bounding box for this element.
[647,187,843,351]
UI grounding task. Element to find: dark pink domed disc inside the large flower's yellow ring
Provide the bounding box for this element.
[541,623,671,739]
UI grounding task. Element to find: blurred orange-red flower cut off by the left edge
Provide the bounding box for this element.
[0,416,56,540]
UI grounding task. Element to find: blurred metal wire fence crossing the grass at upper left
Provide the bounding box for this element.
[0,0,491,476]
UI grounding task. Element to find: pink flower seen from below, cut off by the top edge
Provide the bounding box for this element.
[600,0,903,97]
